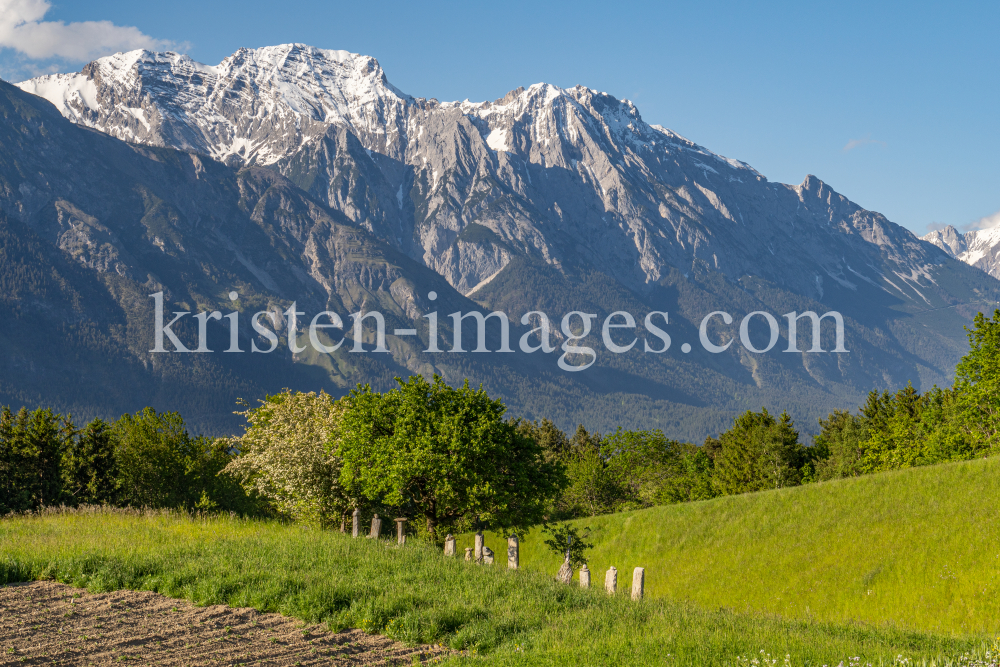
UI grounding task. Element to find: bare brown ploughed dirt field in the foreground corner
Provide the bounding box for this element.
[0,581,445,666]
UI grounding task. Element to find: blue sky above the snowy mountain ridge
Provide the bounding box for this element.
[0,0,1000,234]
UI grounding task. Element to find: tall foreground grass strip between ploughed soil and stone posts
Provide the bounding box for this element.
[0,512,996,666]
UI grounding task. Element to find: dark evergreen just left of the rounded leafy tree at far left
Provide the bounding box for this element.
[62,419,118,505]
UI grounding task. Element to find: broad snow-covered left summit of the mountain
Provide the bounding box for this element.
[19,44,408,165]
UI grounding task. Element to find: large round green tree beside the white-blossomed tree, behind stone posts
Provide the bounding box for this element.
[337,376,565,541]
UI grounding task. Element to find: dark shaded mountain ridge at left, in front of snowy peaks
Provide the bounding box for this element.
[0,78,446,432]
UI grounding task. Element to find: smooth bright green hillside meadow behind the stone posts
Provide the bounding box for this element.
[472,458,1000,636]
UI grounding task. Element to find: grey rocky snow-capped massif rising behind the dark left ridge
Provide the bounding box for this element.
[18,44,940,299]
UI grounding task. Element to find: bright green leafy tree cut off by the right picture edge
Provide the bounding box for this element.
[954,309,1000,452]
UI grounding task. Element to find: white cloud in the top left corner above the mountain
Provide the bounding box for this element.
[0,0,175,61]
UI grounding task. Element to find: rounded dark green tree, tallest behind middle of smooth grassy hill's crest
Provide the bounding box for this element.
[713,409,807,495]
